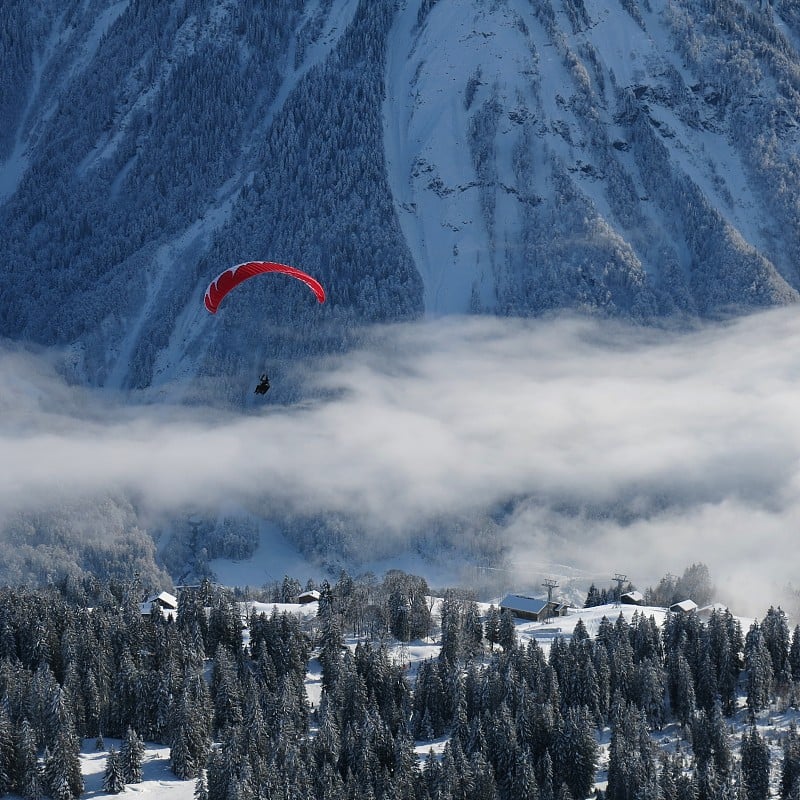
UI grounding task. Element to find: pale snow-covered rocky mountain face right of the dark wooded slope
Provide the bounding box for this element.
[384,0,797,317]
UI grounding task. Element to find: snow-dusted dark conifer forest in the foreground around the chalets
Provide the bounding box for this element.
[0,571,800,800]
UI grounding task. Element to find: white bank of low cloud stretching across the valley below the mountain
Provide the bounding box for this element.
[0,309,800,608]
